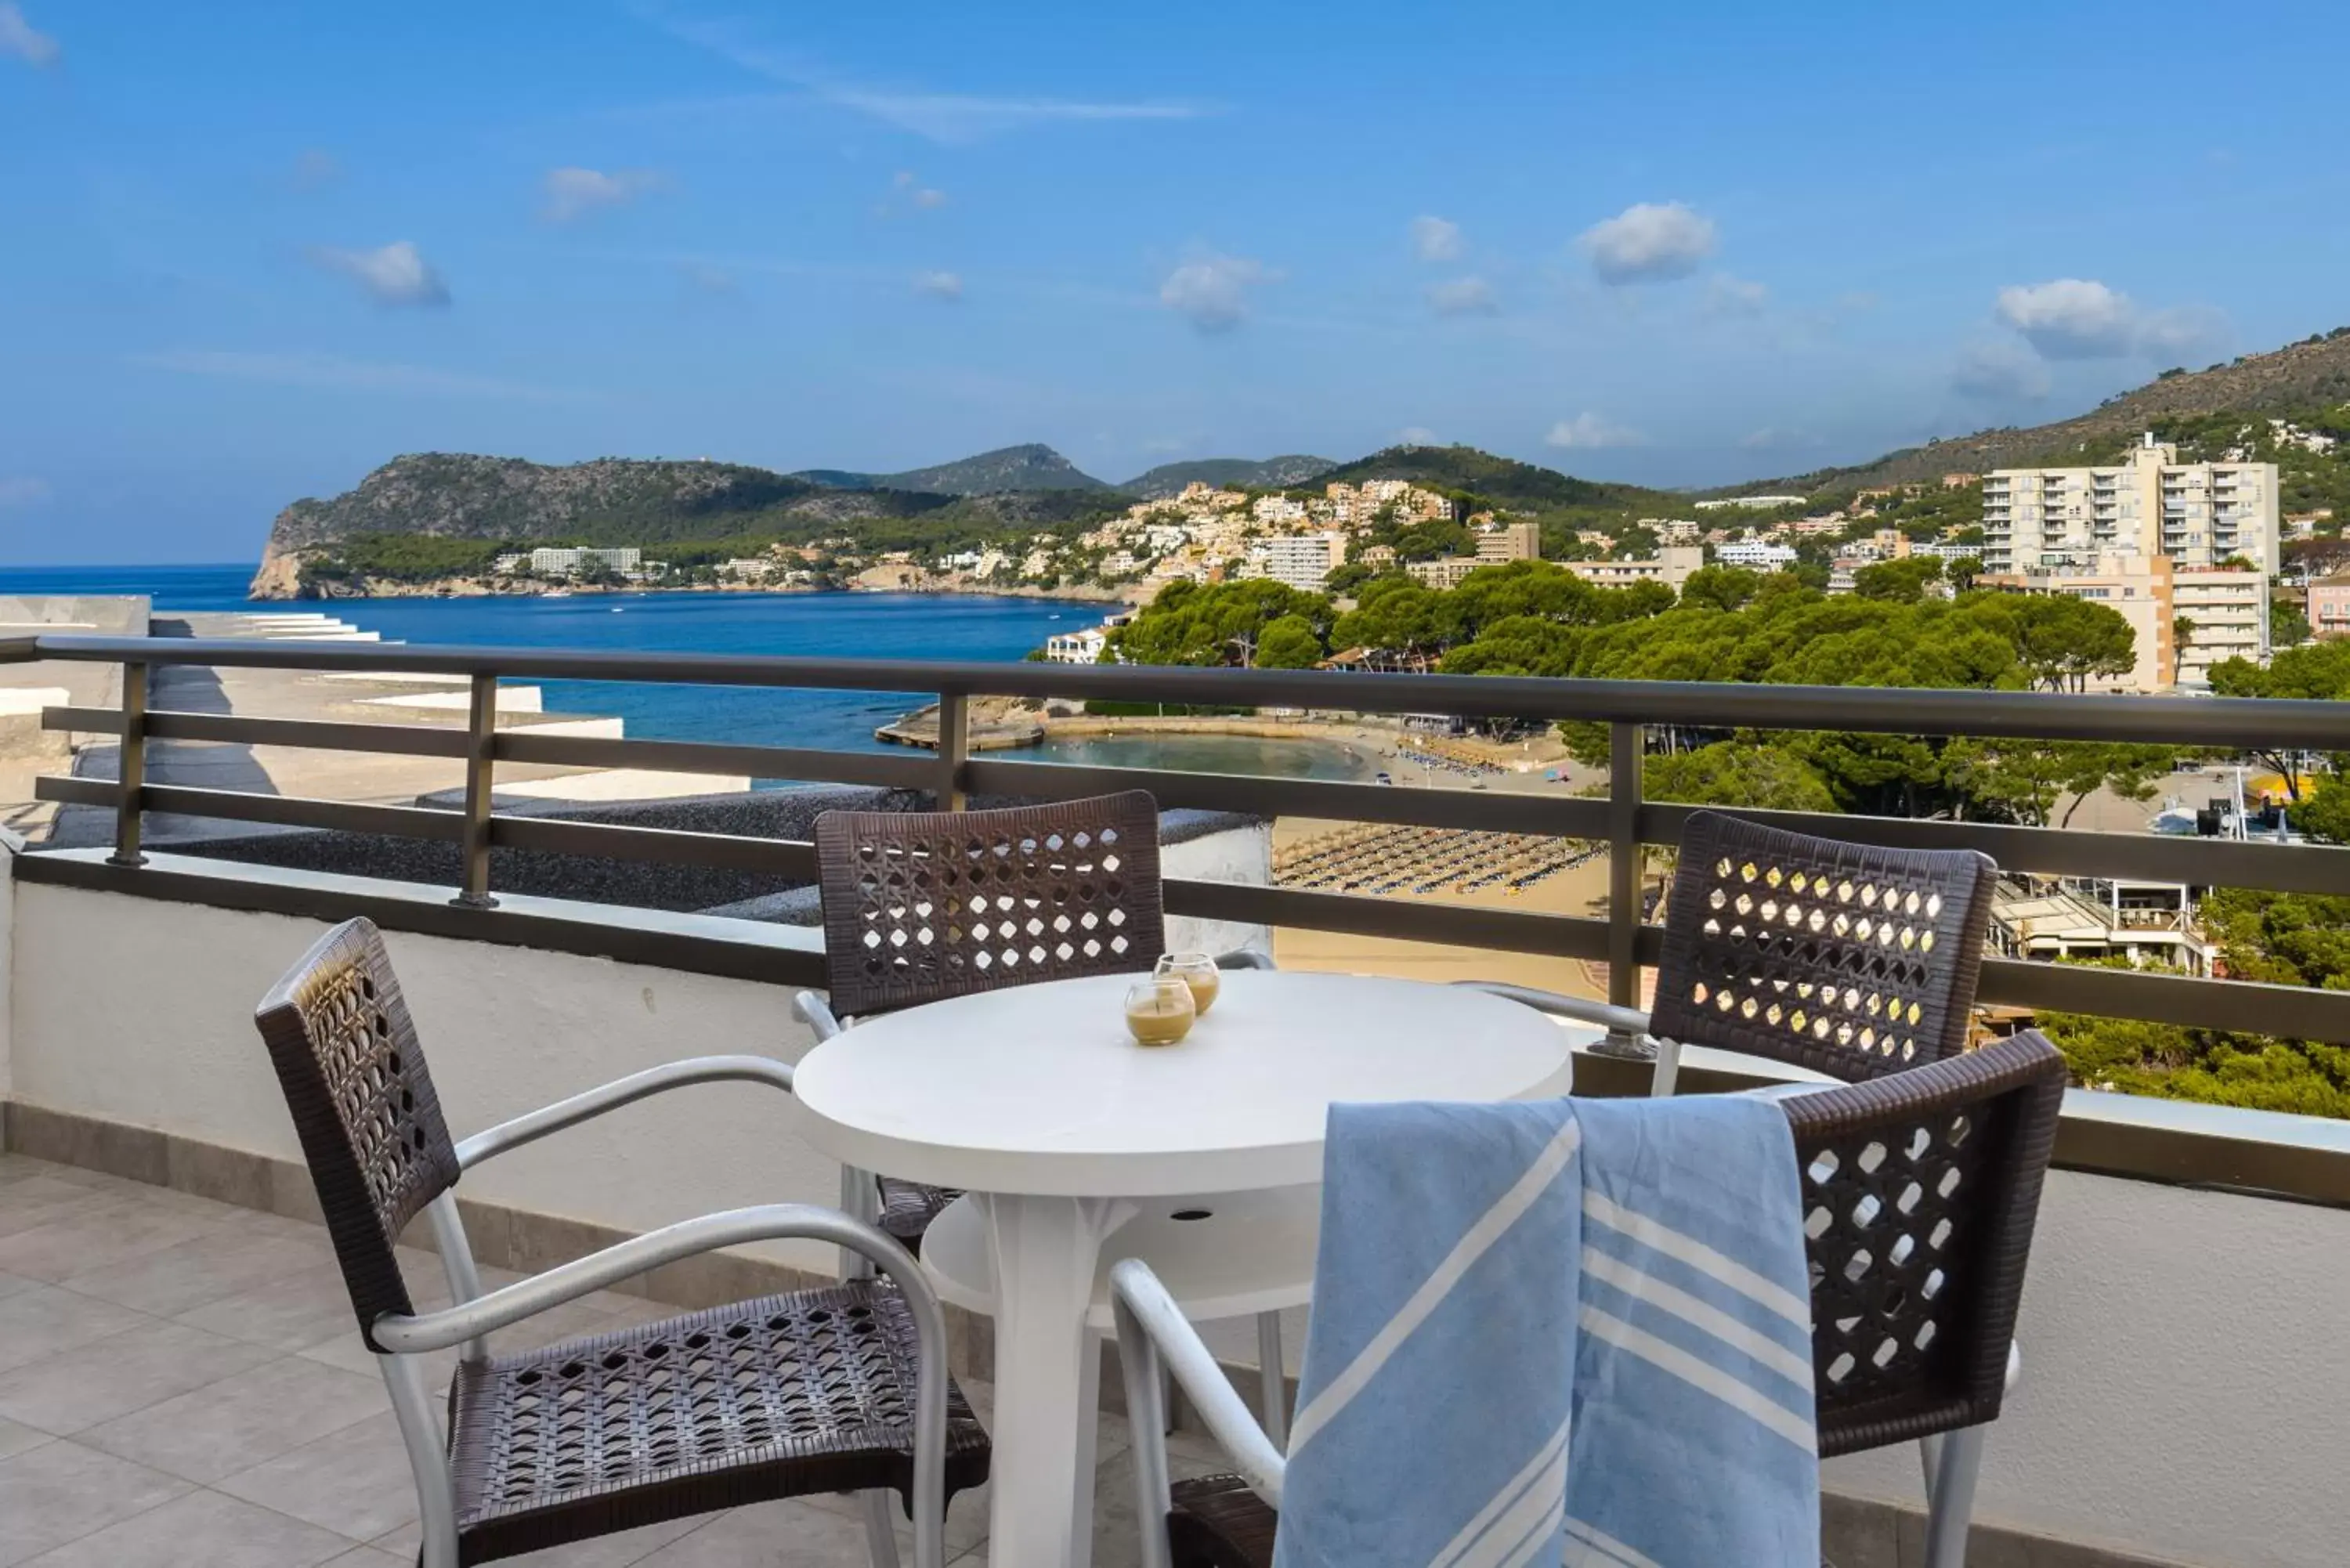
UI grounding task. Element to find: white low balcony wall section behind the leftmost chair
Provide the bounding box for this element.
[12,884,839,1270]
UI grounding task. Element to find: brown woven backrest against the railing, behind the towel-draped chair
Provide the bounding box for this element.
[1650,811,1998,1084]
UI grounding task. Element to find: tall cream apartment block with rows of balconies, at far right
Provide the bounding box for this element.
[1983,435,2277,573]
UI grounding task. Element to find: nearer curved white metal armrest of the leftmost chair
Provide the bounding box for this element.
[369,1204,947,1566]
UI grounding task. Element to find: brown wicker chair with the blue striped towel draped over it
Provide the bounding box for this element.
[1114,1035,2066,1568]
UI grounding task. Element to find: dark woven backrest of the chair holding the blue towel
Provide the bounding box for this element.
[1781,1032,2066,1455]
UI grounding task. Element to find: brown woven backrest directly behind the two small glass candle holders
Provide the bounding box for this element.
[815,790,1166,1018]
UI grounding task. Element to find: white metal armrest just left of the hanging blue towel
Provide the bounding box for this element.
[1109,1258,1288,1532]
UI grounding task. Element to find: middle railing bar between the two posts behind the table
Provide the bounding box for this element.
[966,757,1607,840]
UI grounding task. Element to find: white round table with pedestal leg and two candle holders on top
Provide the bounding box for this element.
[794,971,1589,1568]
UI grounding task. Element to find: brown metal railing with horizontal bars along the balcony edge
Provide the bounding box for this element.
[13,634,2350,1042]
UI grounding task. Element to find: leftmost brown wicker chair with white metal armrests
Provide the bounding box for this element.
[256,919,987,1568]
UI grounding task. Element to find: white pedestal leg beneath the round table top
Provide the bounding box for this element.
[973,1194,1140,1568]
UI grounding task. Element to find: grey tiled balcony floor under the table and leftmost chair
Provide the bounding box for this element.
[0,1154,1215,1568]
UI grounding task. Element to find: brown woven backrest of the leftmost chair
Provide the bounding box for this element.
[254,919,458,1349]
